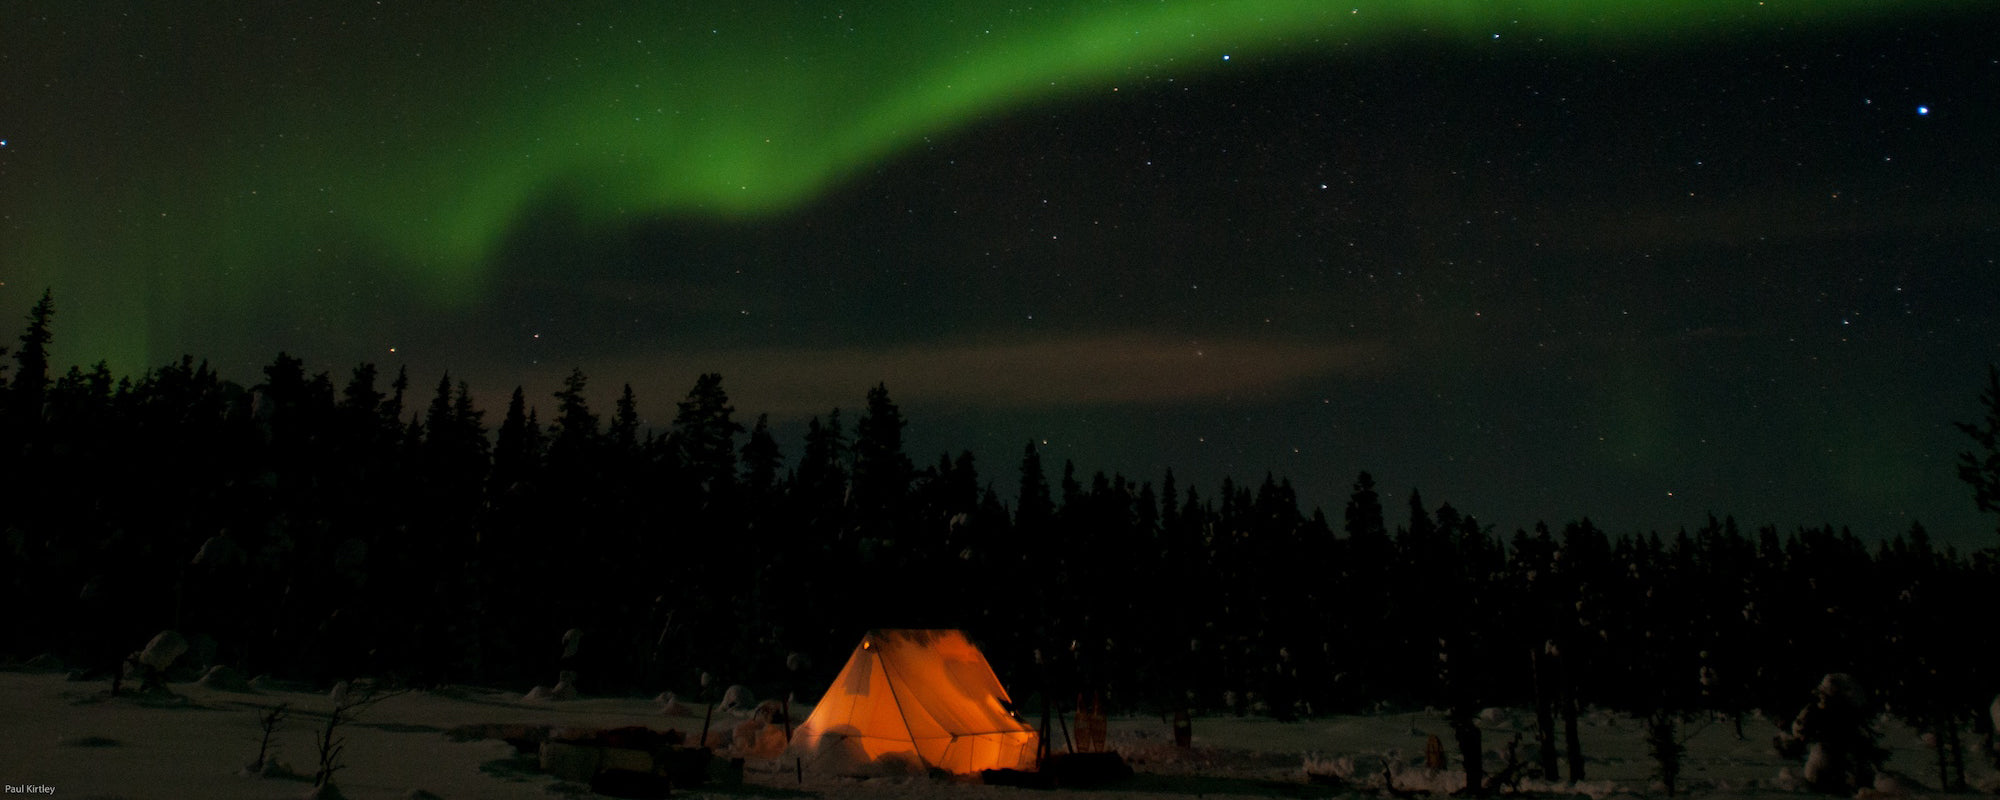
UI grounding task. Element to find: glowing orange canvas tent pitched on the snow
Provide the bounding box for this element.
[794,630,1038,774]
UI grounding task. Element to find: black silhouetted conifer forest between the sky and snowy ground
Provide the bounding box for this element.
[0,296,2000,768]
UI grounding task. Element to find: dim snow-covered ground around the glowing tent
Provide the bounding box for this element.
[0,672,2000,800]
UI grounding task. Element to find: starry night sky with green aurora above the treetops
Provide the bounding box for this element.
[0,0,2000,546]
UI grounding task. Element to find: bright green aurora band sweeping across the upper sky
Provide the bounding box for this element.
[0,0,1968,368]
